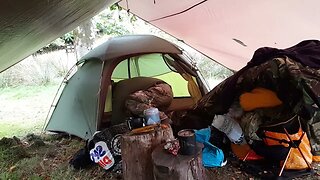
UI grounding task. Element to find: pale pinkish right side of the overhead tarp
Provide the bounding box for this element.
[119,0,320,70]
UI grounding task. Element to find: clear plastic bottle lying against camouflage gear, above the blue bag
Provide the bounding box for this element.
[211,115,245,144]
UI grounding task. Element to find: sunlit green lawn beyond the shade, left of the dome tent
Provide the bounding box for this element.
[0,85,58,138]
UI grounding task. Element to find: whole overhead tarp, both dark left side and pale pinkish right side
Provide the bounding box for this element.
[0,0,320,72]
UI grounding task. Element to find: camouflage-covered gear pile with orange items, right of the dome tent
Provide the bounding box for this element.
[193,40,320,176]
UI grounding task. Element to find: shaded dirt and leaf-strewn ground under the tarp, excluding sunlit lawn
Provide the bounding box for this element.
[0,134,320,180]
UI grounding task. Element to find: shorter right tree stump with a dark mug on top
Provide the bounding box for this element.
[152,143,207,180]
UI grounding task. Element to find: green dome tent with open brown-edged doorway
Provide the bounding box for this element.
[45,35,208,139]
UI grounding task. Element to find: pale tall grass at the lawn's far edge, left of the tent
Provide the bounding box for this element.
[0,51,76,88]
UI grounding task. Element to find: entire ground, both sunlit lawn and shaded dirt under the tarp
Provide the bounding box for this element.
[0,85,320,180]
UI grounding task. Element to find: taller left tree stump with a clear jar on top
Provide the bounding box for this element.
[121,125,174,180]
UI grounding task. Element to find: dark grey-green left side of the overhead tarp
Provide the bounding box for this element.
[0,0,114,72]
